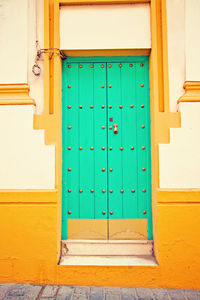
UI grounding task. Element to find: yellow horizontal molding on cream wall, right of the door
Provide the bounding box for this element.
[177,81,200,103]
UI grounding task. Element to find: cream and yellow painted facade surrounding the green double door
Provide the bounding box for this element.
[0,0,200,288]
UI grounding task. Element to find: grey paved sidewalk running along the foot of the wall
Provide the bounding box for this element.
[0,284,200,300]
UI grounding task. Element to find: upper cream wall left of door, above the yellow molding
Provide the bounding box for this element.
[0,0,44,114]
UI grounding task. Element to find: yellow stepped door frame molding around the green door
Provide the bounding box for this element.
[34,0,180,259]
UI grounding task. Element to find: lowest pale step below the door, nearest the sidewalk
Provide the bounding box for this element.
[59,255,158,267]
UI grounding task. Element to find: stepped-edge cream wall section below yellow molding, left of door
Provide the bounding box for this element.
[0,105,55,189]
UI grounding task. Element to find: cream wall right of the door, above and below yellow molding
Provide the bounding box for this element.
[159,0,200,189]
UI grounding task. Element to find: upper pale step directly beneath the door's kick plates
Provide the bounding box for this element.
[62,240,153,256]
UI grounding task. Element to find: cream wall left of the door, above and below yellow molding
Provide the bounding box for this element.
[0,0,55,189]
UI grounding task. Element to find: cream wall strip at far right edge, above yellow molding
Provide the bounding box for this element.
[185,0,200,81]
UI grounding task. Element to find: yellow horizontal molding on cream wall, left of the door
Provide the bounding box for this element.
[0,84,35,105]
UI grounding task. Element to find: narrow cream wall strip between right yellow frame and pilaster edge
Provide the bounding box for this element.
[167,0,185,112]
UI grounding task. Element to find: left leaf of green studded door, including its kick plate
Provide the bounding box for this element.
[63,63,107,238]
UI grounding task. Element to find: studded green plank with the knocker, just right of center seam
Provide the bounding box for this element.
[107,63,123,219]
